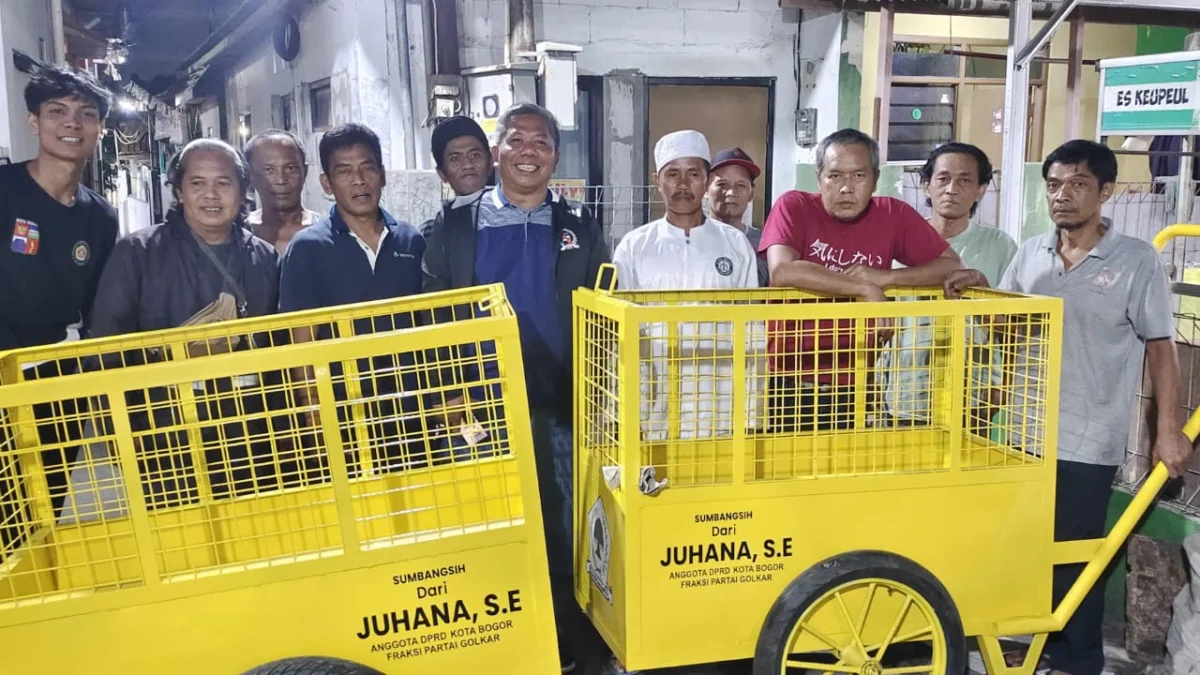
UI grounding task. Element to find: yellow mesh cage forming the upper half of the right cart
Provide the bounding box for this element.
[576,283,1061,490]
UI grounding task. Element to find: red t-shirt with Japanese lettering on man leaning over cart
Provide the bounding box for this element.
[758,190,948,384]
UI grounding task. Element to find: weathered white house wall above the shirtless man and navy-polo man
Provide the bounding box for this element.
[226,0,427,216]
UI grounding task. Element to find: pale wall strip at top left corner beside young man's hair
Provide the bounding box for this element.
[0,0,54,162]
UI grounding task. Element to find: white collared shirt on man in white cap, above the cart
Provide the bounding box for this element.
[612,219,758,291]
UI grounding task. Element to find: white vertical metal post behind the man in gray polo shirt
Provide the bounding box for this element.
[997,0,1033,241]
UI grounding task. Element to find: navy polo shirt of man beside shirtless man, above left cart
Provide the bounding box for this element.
[280,205,425,312]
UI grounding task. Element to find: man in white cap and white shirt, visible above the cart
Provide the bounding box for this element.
[613,131,758,291]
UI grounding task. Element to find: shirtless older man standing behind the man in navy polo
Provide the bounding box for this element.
[242,129,320,256]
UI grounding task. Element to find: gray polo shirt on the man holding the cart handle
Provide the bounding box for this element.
[1000,219,1175,466]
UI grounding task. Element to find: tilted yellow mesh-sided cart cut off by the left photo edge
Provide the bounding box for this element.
[0,286,559,675]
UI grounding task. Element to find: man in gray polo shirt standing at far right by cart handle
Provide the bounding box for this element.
[946,141,1192,675]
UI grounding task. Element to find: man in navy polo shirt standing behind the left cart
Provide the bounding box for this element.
[280,124,427,472]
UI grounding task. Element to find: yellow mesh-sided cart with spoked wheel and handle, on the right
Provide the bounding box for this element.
[574,267,1195,675]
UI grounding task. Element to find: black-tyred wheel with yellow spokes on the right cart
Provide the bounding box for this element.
[754,551,967,675]
